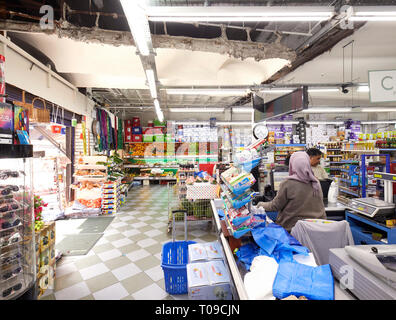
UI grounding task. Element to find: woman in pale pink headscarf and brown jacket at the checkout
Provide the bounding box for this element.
[257,151,326,232]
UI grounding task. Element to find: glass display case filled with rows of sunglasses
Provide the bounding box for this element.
[0,145,36,300]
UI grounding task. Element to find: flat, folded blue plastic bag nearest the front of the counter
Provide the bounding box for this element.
[272,261,334,300]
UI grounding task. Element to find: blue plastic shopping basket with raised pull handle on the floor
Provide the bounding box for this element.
[161,210,196,294]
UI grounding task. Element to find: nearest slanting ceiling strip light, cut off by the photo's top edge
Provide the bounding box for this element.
[120,0,151,56]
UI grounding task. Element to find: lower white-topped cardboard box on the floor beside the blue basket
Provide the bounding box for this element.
[187,260,232,300]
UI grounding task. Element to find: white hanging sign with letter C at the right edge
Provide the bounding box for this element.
[369,70,396,103]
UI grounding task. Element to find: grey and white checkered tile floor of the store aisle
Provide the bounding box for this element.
[41,185,216,300]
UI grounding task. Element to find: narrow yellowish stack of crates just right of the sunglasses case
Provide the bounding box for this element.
[35,221,56,298]
